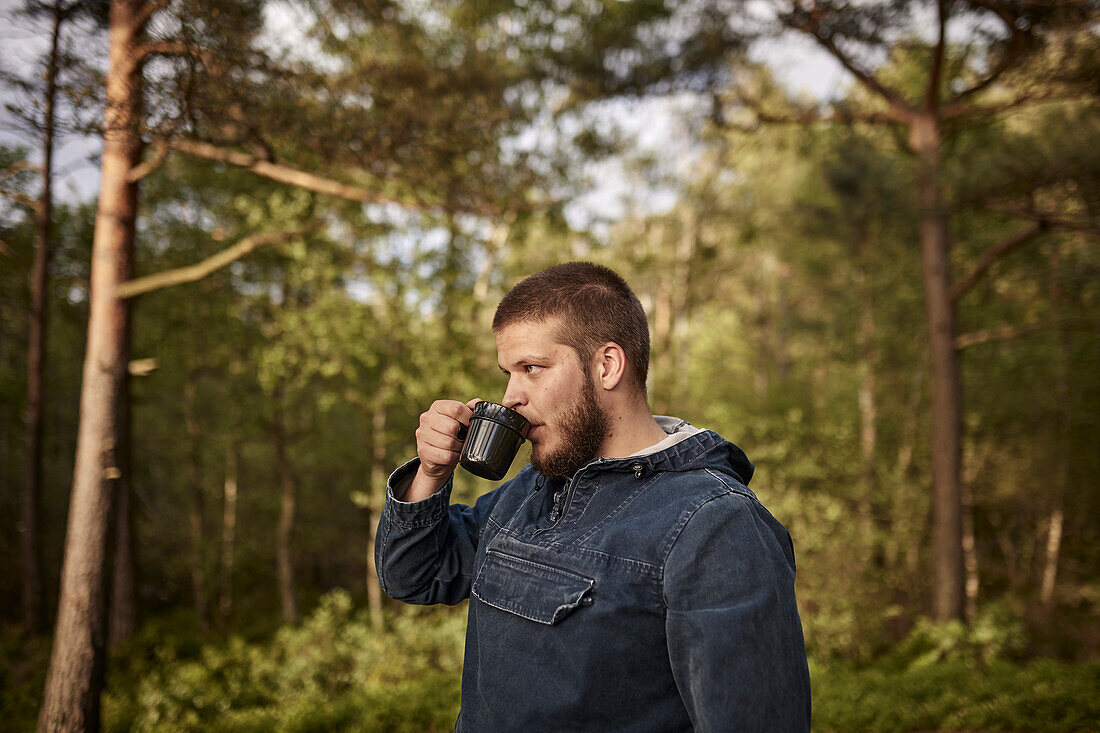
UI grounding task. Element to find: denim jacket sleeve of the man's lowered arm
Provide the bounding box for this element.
[664,492,810,732]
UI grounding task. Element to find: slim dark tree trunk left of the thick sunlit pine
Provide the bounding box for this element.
[19,1,62,634]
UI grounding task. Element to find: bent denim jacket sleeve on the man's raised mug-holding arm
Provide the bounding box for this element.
[374,458,503,605]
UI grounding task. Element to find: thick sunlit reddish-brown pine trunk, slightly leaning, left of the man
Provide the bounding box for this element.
[39,0,141,733]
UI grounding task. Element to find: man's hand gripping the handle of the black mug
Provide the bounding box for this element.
[404,398,481,502]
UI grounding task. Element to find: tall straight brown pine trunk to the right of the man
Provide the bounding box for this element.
[910,113,964,621]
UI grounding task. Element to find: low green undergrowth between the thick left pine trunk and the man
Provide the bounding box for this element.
[103,590,464,733]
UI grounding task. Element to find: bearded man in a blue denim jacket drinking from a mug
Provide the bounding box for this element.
[375,263,810,733]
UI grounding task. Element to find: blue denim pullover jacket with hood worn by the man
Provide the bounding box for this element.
[375,420,810,733]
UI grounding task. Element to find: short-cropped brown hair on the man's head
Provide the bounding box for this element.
[493,262,649,395]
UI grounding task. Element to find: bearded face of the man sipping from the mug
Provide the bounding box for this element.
[496,320,608,478]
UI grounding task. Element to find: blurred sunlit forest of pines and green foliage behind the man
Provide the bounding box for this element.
[0,0,1100,732]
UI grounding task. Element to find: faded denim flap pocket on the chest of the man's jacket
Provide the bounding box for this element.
[472,549,596,625]
